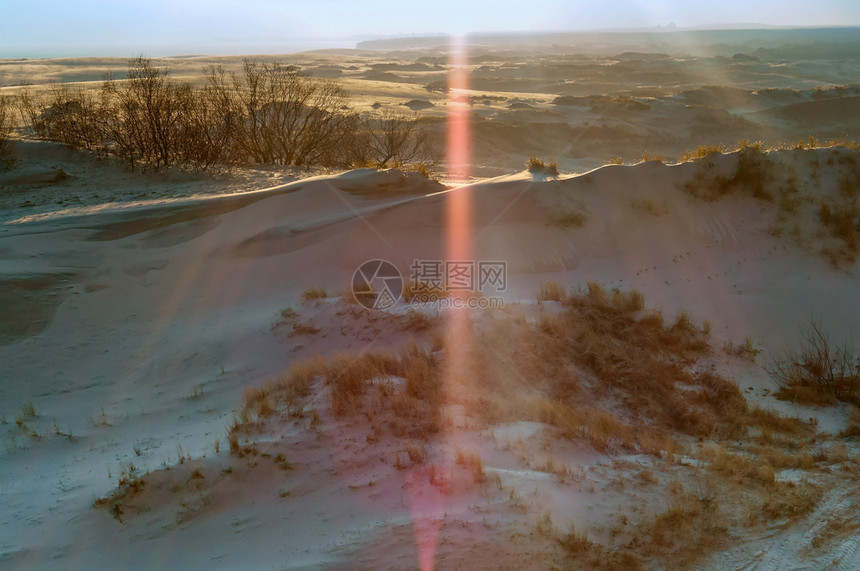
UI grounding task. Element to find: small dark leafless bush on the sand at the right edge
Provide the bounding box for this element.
[768,320,860,402]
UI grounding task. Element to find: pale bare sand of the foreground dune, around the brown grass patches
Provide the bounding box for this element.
[0,142,860,569]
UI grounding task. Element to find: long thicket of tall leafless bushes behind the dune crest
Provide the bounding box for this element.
[21,57,436,174]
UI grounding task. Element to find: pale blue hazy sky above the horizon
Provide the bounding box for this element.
[0,0,860,58]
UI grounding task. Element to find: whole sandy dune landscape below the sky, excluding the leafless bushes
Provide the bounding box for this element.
[0,29,860,570]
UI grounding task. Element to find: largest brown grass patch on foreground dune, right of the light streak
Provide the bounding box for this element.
[466,282,748,455]
